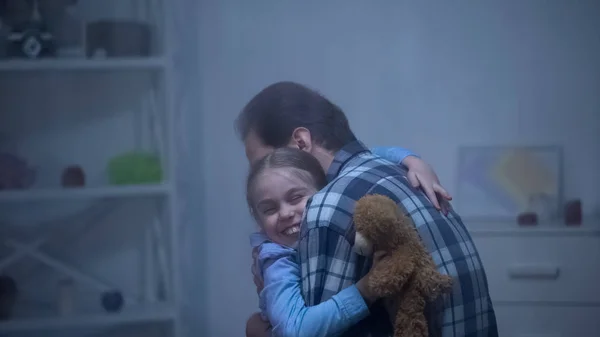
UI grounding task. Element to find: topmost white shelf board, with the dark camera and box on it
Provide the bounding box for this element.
[0,57,167,72]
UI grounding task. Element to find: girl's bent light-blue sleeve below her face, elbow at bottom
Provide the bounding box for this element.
[260,256,369,337]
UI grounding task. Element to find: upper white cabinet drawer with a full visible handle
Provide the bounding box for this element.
[474,237,600,303]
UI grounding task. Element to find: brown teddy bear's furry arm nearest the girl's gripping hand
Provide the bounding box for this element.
[368,247,415,298]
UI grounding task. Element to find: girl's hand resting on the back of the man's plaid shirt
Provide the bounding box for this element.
[402,156,452,215]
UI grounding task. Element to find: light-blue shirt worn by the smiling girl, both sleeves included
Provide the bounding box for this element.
[250,147,414,337]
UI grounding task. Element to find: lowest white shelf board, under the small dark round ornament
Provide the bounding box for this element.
[0,308,176,334]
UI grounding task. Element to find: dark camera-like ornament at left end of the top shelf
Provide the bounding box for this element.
[7,0,55,59]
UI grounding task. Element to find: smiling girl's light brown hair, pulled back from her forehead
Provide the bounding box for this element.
[246,147,327,216]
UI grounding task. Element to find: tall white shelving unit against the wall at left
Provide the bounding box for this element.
[0,0,182,337]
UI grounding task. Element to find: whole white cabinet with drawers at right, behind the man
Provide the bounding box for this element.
[469,220,600,337]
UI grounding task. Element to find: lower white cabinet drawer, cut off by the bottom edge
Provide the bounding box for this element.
[495,305,600,337]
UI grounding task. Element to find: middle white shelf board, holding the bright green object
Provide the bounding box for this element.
[0,184,170,203]
